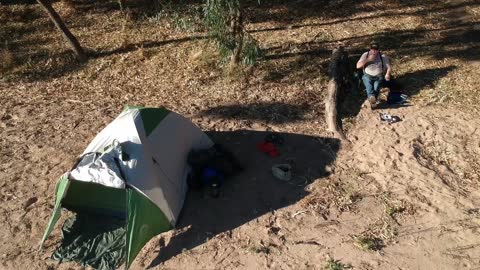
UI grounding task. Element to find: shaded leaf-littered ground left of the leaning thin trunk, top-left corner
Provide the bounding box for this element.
[0,4,87,81]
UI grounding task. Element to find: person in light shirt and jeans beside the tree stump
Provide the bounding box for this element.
[357,42,392,109]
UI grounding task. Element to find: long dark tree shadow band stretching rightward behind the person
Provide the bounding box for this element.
[265,22,480,68]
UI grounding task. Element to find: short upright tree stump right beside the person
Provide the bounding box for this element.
[325,47,349,141]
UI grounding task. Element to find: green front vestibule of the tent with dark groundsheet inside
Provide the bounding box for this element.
[50,181,172,269]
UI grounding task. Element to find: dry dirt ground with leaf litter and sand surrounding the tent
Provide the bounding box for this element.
[0,0,480,270]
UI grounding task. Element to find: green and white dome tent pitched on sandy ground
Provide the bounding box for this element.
[42,107,213,268]
